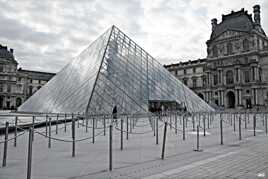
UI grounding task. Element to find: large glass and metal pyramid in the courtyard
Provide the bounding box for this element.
[18,26,213,114]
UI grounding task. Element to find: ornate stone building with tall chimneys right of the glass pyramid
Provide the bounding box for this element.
[165,5,268,109]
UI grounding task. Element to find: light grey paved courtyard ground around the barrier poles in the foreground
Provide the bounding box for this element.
[0,114,268,179]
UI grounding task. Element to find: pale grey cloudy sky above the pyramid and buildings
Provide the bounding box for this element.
[0,0,268,72]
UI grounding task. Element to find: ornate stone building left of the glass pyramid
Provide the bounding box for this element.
[0,45,55,110]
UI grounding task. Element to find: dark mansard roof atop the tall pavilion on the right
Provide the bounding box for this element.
[210,8,265,40]
